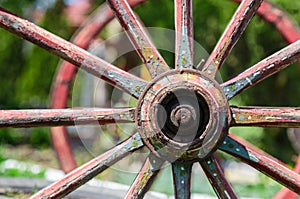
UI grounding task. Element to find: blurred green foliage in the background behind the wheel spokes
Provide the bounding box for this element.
[0,0,300,166]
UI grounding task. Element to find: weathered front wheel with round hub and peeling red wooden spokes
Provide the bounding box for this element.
[0,0,300,198]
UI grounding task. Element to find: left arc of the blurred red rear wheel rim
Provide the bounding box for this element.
[51,0,145,173]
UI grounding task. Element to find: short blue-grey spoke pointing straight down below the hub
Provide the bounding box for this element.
[172,162,193,199]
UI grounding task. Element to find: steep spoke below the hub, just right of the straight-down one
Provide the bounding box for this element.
[200,156,238,199]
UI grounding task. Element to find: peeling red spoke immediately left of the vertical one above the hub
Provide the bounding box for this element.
[107,0,169,78]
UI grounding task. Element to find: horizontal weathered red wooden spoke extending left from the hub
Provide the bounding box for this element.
[0,108,134,128]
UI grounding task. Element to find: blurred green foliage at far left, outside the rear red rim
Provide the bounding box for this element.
[0,0,71,147]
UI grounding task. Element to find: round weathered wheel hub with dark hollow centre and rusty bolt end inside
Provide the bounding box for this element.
[135,69,230,161]
